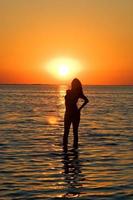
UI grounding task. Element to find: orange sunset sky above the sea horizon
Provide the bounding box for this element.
[0,0,133,85]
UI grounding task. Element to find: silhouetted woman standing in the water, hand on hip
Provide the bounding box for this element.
[63,78,88,148]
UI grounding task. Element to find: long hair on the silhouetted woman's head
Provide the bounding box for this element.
[71,78,83,95]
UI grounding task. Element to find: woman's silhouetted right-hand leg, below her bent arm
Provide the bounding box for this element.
[72,113,80,148]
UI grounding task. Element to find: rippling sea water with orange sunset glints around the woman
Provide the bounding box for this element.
[0,85,133,200]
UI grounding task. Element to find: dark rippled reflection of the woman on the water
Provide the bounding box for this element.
[62,149,85,199]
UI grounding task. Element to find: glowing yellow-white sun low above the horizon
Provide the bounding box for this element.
[46,57,81,80]
